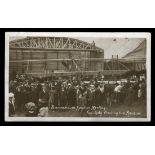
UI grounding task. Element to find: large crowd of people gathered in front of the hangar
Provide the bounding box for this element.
[9,74,146,116]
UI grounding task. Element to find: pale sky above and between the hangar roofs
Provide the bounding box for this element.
[10,37,144,58]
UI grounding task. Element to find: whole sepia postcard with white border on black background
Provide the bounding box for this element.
[5,32,151,122]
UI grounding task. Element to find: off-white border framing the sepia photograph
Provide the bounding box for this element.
[4,32,151,122]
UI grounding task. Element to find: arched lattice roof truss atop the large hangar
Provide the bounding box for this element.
[10,37,103,52]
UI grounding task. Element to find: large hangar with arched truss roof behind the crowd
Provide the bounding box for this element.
[9,37,145,77]
